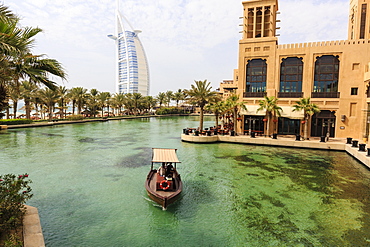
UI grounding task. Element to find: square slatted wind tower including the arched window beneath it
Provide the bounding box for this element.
[237,0,279,98]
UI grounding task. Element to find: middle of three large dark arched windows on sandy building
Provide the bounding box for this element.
[279,57,303,98]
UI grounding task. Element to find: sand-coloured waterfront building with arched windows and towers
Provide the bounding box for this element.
[234,0,370,139]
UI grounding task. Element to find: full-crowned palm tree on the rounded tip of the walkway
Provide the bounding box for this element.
[187,80,218,131]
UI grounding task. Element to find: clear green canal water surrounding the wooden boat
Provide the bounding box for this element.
[0,117,370,247]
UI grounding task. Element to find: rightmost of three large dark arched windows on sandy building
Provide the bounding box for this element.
[313,55,339,93]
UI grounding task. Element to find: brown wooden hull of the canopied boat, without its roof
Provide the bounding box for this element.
[145,170,182,209]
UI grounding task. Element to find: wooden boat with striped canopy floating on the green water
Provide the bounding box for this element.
[145,148,182,209]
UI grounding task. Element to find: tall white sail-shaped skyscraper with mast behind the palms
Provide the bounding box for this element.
[108,0,149,96]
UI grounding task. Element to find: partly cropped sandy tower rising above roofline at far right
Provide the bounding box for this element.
[348,0,370,40]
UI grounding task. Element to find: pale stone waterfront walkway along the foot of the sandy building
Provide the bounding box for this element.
[181,134,370,168]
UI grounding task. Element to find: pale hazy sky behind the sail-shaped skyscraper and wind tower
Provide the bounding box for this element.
[0,0,349,96]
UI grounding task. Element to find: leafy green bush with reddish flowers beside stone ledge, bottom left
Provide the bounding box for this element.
[0,174,33,235]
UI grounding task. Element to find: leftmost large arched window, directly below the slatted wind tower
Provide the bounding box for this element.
[246,59,267,97]
